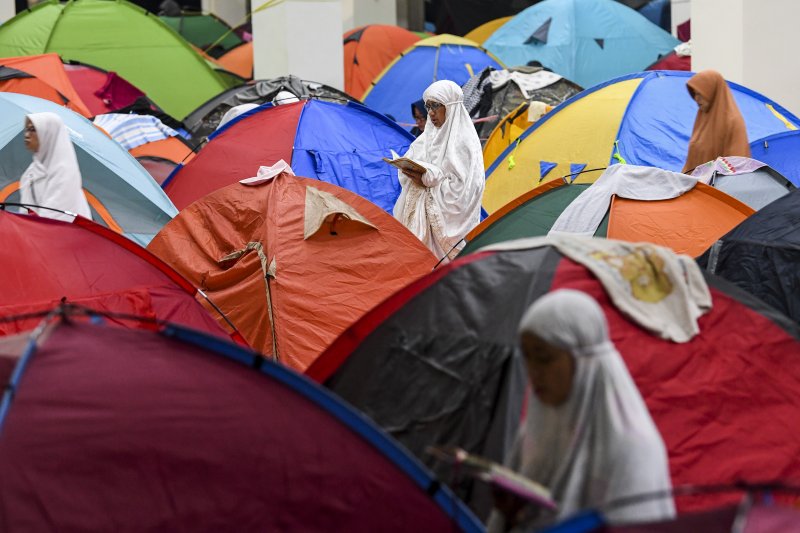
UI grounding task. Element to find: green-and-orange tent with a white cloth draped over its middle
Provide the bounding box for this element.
[461,168,754,257]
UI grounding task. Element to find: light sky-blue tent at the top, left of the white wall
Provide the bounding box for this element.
[484,0,679,87]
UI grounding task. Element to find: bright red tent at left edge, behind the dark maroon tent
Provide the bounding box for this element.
[0,211,228,337]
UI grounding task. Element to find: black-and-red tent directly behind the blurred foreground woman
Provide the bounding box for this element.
[307,240,800,510]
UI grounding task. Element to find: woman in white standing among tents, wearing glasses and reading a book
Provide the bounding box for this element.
[394,80,485,259]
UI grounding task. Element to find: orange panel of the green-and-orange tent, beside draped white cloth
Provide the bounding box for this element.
[607,183,755,257]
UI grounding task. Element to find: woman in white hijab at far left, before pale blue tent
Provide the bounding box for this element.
[19,113,92,222]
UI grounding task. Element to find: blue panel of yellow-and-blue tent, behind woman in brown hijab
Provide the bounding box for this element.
[609,71,800,170]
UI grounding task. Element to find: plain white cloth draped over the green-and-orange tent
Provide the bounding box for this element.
[548,165,697,235]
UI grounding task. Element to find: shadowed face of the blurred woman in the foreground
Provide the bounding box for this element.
[521,333,575,407]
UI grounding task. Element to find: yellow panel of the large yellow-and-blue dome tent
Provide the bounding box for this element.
[483,78,642,213]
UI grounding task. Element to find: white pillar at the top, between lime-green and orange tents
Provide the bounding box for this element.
[252,0,344,89]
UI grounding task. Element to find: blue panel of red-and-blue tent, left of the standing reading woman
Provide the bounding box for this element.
[291,99,414,213]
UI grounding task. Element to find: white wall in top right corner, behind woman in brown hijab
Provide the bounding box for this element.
[692,0,800,115]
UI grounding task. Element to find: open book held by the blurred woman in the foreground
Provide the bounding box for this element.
[427,446,558,510]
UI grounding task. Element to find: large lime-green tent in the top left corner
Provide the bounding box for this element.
[0,0,233,118]
